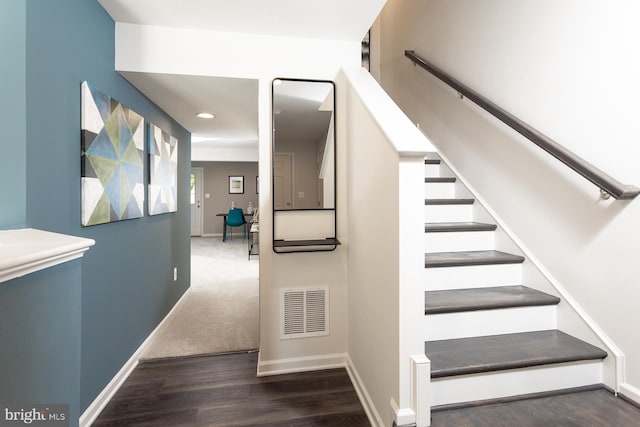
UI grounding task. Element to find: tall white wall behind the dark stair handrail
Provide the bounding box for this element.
[372,0,640,400]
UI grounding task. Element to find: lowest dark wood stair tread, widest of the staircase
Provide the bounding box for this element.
[425,329,607,378]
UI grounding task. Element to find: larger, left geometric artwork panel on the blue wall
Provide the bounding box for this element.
[80,82,144,226]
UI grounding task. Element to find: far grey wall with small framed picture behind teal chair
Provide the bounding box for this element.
[191,162,259,235]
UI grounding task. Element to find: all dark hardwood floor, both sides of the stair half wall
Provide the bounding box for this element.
[93,353,640,427]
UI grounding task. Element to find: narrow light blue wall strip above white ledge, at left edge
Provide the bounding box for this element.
[0,0,27,230]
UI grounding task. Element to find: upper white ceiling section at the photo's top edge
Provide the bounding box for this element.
[98,0,384,41]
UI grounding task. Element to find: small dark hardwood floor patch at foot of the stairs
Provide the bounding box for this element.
[431,389,640,427]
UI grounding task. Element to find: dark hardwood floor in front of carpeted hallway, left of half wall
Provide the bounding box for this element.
[93,353,370,427]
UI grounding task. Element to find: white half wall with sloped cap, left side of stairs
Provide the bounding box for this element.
[337,69,433,425]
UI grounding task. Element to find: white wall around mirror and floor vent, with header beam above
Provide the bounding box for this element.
[116,23,360,374]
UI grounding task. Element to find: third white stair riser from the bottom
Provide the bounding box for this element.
[424,264,522,291]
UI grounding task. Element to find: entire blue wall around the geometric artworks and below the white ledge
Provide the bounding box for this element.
[0,0,191,426]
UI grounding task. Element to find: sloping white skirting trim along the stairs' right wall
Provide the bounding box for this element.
[425,149,625,391]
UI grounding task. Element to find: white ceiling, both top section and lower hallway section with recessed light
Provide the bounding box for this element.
[97,0,386,154]
